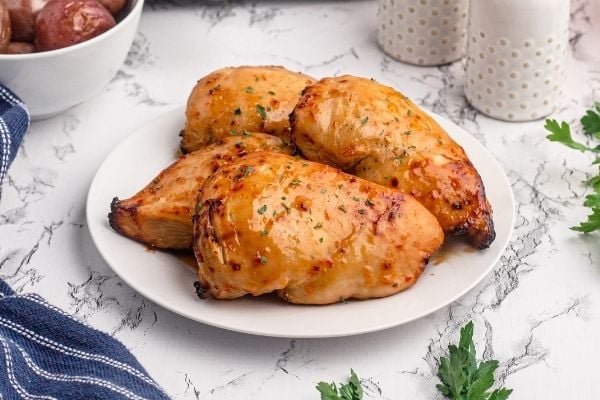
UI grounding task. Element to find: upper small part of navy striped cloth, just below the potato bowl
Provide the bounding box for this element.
[0,85,29,189]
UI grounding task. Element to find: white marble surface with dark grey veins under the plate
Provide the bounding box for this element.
[0,0,600,399]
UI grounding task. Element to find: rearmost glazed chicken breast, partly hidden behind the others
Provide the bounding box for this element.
[181,67,314,153]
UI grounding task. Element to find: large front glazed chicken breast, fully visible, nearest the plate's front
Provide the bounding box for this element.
[194,152,444,304]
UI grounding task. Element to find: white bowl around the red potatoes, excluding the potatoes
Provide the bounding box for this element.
[0,0,144,119]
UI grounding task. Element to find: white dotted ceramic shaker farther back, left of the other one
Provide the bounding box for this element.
[377,0,472,65]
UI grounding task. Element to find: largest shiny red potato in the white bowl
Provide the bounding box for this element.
[35,0,116,51]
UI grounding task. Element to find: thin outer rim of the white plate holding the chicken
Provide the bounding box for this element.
[85,105,516,339]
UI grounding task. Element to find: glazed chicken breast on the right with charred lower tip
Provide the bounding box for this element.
[292,76,495,249]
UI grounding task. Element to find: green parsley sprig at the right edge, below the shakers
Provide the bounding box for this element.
[544,103,600,233]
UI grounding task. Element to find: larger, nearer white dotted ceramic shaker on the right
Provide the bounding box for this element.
[465,0,569,121]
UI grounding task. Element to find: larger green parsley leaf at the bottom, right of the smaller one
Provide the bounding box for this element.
[436,321,512,400]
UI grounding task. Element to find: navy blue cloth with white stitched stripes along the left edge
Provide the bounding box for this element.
[0,83,169,400]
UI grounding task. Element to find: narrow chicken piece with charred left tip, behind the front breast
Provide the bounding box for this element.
[108,133,292,249]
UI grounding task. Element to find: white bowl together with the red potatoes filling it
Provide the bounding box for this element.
[0,0,144,120]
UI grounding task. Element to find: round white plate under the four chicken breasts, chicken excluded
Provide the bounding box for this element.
[87,108,514,338]
